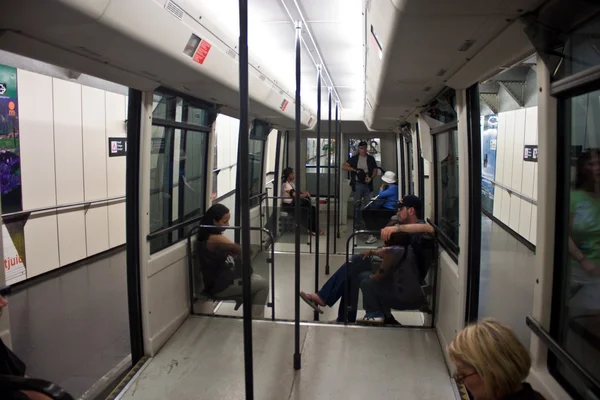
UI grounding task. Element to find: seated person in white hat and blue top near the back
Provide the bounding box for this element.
[362,171,398,231]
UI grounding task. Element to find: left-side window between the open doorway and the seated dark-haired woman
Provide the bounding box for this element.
[150,94,214,254]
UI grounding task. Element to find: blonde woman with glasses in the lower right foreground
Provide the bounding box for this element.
[447,319,544,400]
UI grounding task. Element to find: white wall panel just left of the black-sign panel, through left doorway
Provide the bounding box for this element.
[81,86,109,257]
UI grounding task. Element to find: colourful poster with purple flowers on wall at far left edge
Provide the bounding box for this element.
[0,65,26,285]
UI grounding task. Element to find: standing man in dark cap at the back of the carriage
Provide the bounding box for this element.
[342,141,377,244]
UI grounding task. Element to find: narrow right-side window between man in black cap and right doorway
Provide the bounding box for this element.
[434,130,458,247]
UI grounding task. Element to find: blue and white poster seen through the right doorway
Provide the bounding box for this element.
[481,114,498,214]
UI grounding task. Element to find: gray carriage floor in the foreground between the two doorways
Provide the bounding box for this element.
[122,317,455,400]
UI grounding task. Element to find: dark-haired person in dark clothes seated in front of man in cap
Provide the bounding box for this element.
[359,232,425,324]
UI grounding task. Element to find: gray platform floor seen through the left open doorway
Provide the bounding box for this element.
[9,250,130,398]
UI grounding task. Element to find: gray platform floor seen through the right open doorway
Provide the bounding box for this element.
[479,214,535,347]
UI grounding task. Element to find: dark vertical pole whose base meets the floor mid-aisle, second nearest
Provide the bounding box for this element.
[294,21,302,370]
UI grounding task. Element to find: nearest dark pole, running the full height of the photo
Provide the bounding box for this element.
[238,0,254,400]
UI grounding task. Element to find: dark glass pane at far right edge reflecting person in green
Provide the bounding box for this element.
[551,87,600,397]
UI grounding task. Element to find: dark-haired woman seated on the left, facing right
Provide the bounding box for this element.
[196,204,269,318]
